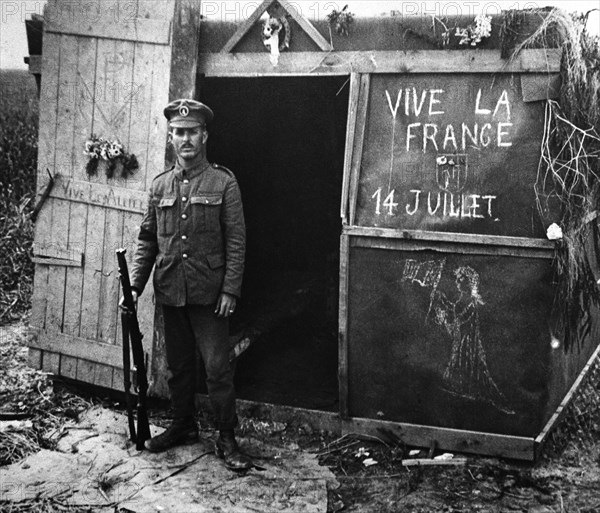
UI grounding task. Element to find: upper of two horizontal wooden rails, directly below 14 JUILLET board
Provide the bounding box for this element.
[344,226,554,251]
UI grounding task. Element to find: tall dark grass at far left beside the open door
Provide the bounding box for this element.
[0,70,38,324]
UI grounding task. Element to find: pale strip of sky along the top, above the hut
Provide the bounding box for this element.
[0,0,600,69]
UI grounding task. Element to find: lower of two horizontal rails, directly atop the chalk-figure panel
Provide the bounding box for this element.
[351,237,554,260]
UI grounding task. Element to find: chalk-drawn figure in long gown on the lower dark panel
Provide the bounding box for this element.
[432,266,515,414]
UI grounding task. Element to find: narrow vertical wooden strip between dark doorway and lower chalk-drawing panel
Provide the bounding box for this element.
[338,233,350,418]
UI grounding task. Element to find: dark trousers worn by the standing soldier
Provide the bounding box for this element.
[162,305,238,430]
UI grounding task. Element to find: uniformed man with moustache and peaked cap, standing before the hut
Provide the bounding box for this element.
[124,99,252,470]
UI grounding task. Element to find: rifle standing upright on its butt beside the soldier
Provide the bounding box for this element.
[117,249,150,451]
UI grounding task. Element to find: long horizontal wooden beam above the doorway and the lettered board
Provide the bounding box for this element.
[198,48,562,77]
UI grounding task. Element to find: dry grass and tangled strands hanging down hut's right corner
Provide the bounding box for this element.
[509,9,600,349]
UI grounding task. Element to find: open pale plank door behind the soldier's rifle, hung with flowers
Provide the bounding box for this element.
[30,0,174,389]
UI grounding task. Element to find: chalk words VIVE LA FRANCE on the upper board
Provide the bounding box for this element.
[385,87,513,153]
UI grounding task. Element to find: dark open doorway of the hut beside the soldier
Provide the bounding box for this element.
[200,77,349,411]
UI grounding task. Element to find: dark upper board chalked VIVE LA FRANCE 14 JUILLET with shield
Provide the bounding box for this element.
[356,74,544,238]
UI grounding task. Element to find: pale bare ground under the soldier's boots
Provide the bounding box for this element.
[0,407,337,513]
